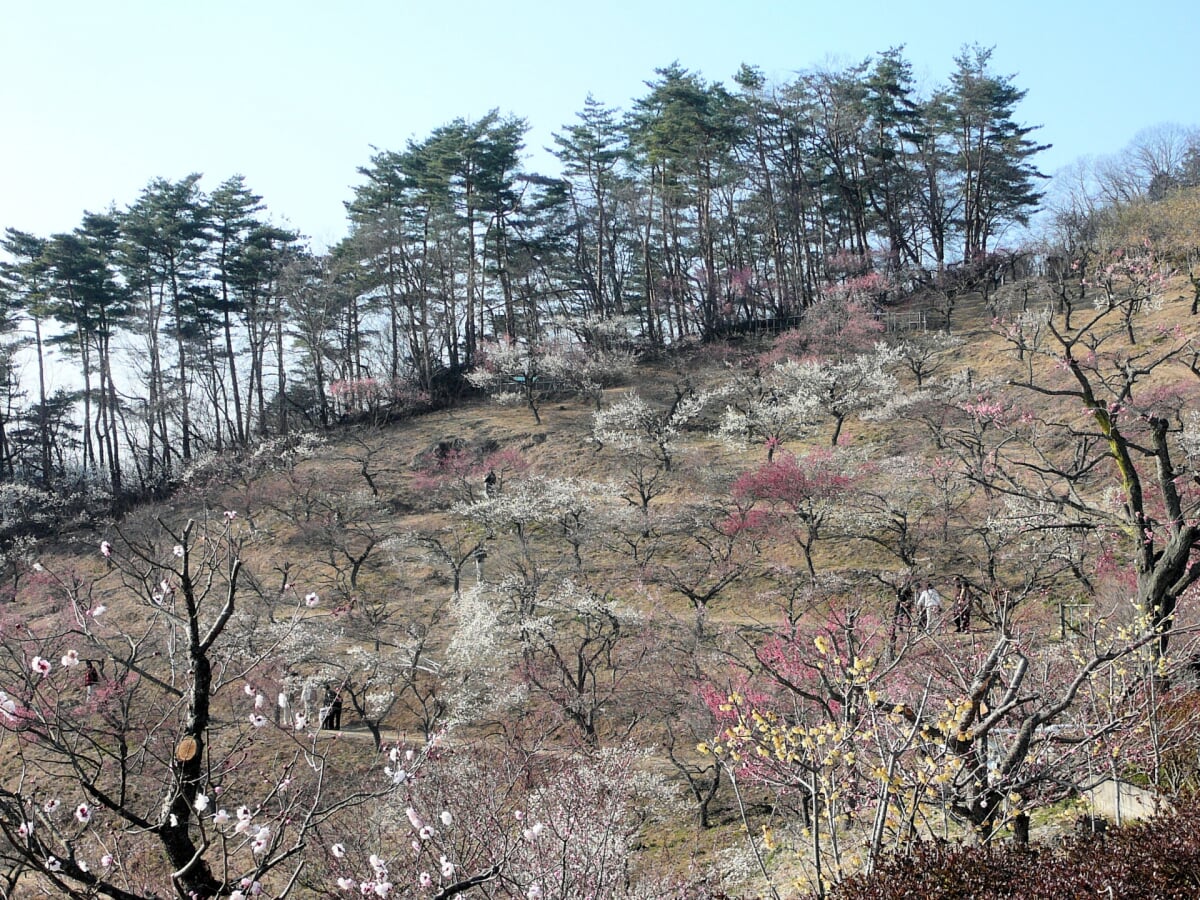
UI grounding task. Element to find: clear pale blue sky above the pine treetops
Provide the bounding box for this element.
[0,0,1200,248]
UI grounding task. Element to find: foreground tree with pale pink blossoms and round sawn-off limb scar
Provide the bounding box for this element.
[0,512,376,899]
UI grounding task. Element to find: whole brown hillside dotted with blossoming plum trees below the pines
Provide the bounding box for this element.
[0,282,1200,898]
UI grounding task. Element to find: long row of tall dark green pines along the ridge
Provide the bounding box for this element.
[0,46,1194,513]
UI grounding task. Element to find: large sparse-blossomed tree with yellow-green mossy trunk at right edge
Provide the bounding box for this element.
[988,301,1200,658]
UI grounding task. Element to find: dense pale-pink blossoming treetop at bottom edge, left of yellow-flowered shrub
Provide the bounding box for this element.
[307,742,674,900]
